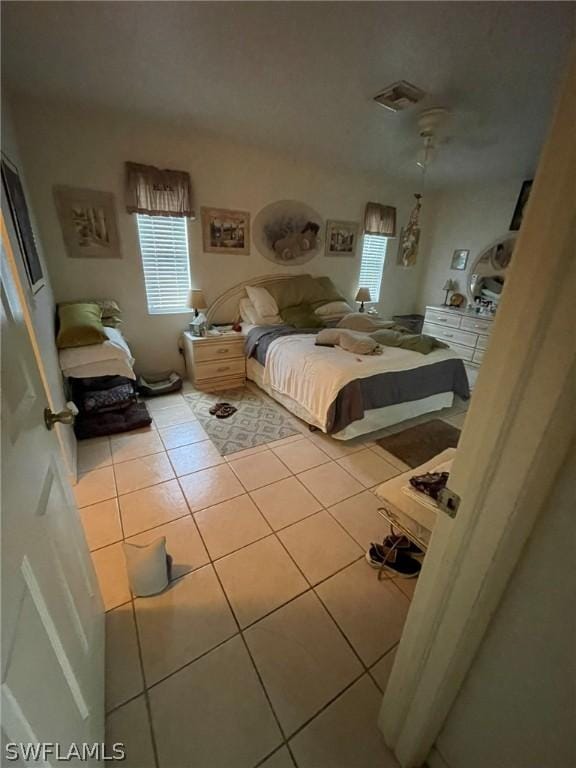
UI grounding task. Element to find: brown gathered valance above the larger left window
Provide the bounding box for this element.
[126,163,195,219]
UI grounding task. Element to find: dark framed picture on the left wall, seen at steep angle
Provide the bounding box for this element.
[2,155,45,293]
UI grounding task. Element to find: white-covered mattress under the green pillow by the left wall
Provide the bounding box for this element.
[58,327,136,379]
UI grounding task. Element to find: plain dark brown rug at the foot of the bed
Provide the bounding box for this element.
[376,419,460,467]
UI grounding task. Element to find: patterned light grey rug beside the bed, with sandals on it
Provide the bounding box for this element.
[184,387,300,456]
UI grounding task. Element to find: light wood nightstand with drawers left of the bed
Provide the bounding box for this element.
[184,331,246,392]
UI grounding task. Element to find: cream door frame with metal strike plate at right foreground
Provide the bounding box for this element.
[379,51,576,768]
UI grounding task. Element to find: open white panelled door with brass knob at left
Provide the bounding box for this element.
[0,222,104,766]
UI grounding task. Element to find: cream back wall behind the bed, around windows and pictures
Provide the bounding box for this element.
[9,101,428,370]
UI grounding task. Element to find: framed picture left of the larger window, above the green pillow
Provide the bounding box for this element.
[54,187,122,259]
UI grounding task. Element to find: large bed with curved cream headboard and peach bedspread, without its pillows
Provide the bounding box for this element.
[208,275,469,440]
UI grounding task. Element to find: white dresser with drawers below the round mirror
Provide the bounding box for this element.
[422,306,494,366]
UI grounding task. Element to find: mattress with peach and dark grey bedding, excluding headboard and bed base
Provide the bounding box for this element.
[247,329,469,434]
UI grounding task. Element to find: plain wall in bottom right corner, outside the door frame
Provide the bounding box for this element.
[430,449,576,768]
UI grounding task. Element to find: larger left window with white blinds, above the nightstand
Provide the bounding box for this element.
[136,214,190,315]
